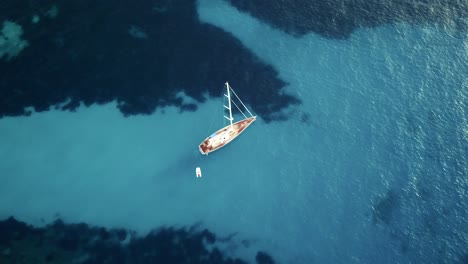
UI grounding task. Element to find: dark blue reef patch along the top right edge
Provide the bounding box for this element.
[229,0,468,39]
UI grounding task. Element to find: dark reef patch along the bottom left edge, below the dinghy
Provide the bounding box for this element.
[0,218,274,264]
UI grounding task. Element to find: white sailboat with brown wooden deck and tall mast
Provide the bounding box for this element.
[198,82,257,155]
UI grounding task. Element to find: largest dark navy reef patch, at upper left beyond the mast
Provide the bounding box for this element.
[0,0,299,121]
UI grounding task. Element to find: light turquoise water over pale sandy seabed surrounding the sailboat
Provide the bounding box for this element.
[0,0,468,263]
